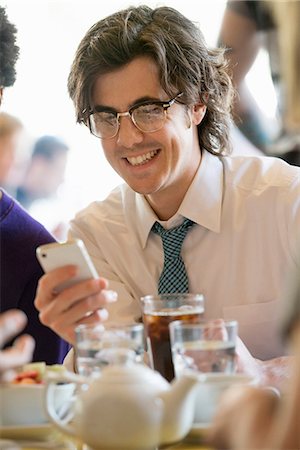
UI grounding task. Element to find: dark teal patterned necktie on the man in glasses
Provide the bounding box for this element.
[152,219,194,294]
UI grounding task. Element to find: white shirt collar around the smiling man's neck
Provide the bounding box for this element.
[135,150,223,248]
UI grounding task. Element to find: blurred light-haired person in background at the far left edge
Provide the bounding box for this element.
[0,112,23,187]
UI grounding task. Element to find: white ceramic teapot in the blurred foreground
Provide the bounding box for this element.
[46,352,198,450]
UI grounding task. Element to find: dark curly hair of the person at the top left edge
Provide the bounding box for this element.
[0,6,19,87]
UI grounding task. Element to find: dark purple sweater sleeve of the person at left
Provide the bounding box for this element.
[0,192,70,364]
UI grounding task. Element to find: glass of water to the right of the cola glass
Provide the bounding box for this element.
[169,319,238,376]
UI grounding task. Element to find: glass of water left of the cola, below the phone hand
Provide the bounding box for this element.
[75,323,144,377]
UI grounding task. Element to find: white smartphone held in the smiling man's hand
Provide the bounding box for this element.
[36,239,99,292]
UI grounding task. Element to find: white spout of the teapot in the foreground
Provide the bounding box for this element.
[160,371,199,444]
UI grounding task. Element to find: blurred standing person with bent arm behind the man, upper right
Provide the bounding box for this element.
[219,0,300,165]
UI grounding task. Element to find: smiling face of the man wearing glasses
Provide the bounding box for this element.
[92,57,205,211]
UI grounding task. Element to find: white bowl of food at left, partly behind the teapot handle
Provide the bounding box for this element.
[0,383,74,427]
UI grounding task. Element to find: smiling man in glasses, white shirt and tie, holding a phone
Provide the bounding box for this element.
[36,6,300,385]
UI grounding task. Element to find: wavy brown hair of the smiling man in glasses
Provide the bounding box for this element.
[68,6,233,154]
